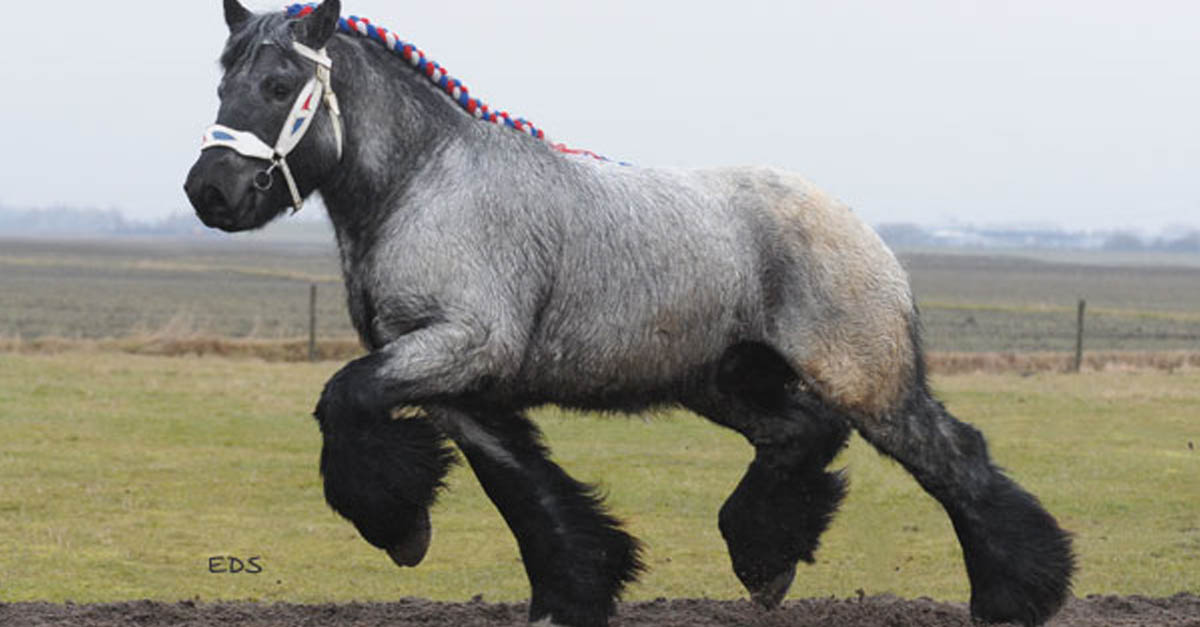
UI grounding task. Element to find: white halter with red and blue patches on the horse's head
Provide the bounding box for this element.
[200,42,342,213]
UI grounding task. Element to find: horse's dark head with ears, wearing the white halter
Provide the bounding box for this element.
[184,0,342,232]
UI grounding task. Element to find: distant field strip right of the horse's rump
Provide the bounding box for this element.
[901,253,1200,352]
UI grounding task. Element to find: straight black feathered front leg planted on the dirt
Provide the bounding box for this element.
[431,407,642,627]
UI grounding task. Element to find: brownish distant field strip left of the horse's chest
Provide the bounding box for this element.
[0,240,353,339]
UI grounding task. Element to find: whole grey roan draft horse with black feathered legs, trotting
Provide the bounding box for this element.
[185,0,1074,626]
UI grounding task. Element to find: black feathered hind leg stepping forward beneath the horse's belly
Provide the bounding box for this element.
[688,344,850,608]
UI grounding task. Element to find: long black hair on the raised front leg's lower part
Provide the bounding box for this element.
[314,358,455,566]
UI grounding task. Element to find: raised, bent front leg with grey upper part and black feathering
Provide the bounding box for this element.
[316,323,494,566]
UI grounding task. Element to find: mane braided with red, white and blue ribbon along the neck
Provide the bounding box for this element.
[286,2,628,165]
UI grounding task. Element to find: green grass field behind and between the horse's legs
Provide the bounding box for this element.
[0,352,1200,602]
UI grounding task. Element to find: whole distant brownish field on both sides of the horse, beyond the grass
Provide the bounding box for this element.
[0,239,1200,352]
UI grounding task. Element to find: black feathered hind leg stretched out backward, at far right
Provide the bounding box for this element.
[854,377,1074,625]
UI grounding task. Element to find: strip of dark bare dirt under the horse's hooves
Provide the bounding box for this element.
[0,593,1200,627]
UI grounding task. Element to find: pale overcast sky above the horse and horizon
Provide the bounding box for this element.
[0,0,1200,233]
